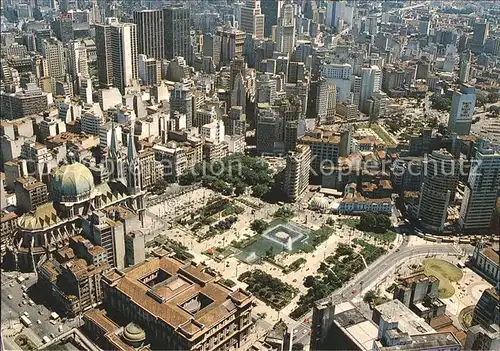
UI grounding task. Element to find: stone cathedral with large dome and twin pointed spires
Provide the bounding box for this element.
[9,125,145,271]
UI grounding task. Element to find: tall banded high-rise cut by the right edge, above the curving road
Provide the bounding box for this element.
[459,140,500,234]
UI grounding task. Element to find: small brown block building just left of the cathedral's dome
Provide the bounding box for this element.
[14,176,49,213]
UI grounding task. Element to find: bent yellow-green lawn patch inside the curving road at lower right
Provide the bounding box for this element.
[424,258,463,299]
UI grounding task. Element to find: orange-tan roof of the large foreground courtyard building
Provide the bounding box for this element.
[103,257,253,339]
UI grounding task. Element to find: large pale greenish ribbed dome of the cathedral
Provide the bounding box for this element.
[52,162,94,202]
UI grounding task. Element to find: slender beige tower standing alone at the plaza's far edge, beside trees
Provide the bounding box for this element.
[283,144,311,201]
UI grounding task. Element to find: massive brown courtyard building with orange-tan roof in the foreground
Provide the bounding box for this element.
[102,256,254,351]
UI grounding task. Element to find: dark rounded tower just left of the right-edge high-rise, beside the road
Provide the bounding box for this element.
[417,149,459,232]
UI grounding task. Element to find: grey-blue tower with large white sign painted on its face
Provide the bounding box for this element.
[448,84,476,135]
